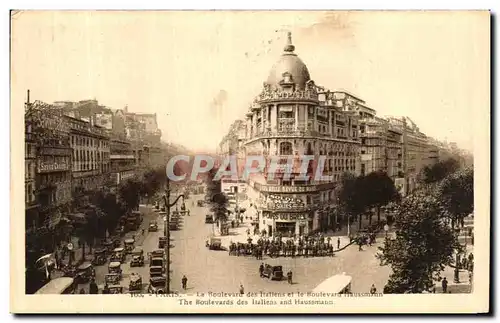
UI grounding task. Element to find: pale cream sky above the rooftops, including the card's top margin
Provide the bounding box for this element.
[11,11,490,151]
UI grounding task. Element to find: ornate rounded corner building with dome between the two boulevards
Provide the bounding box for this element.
[242,33,360,236]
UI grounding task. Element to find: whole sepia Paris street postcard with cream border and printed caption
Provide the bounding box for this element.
[10,10,491,313]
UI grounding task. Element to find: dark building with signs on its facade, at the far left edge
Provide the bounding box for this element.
[25,100,72,250]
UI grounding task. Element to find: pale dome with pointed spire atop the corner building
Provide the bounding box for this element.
[266,33,311,90]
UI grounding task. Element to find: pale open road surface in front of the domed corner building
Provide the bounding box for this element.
[90,195,390,294]
